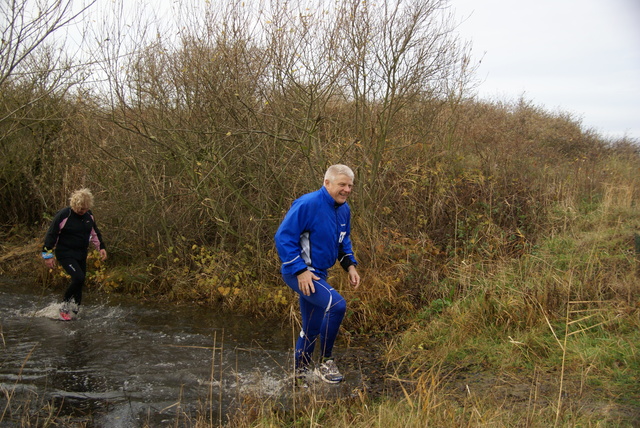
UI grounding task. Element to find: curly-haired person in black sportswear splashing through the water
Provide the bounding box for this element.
[42,189,107,320]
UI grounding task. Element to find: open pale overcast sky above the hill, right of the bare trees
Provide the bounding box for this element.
[450,0,640,142]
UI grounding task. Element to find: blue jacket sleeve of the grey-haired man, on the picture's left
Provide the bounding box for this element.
[275,201,309,275]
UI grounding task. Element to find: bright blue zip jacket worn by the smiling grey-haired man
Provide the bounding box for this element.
[275,186,358,277]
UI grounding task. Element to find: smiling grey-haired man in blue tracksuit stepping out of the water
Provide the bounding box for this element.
[275,165,360,383]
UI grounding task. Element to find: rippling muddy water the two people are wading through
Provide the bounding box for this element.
[0,277,358,427]
